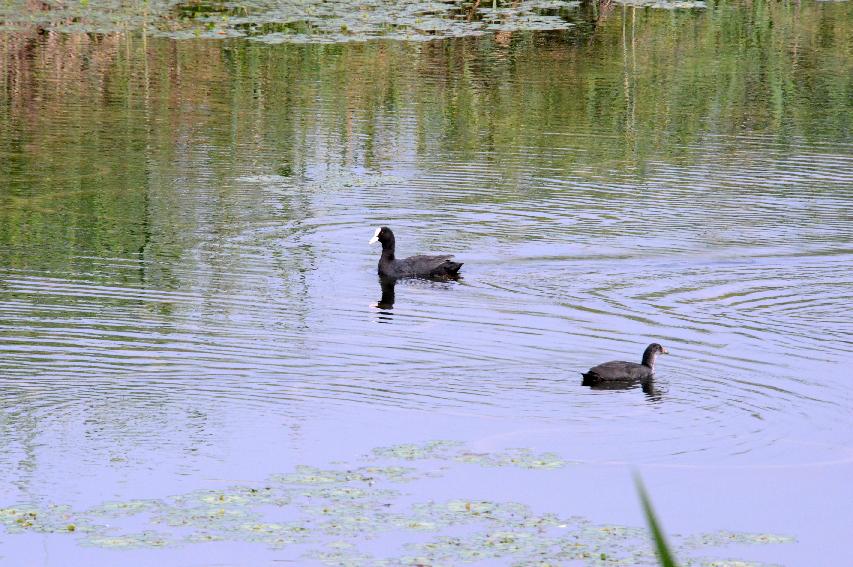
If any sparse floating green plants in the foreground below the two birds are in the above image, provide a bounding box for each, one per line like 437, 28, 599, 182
0, 440, 793, 567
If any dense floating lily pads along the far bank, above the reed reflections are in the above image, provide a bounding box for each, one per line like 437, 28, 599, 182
0, 0, 704, 44
